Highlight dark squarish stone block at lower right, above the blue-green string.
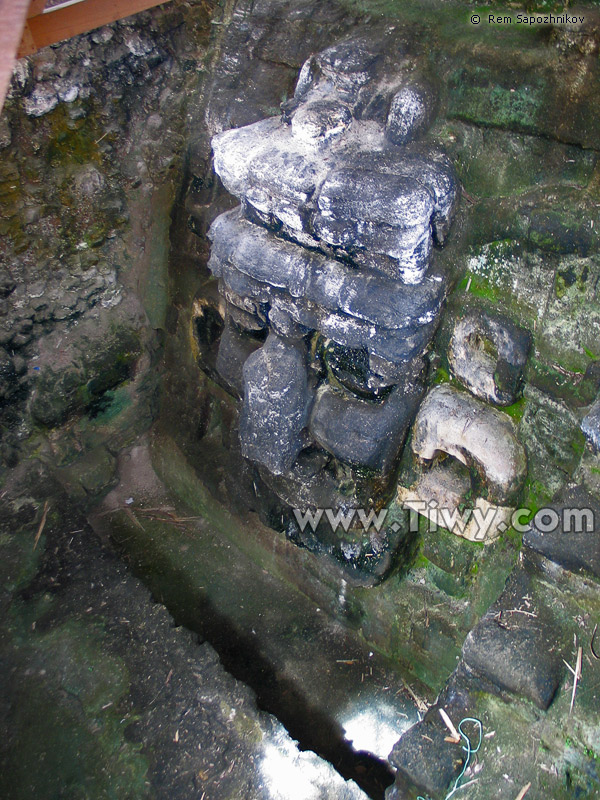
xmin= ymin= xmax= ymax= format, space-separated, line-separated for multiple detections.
xmin=462 ymin=568 xmax=564 ymax=710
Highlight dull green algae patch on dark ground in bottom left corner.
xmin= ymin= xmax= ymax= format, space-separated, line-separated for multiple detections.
xmin=0 ymin=622 xmax=149 ymax=800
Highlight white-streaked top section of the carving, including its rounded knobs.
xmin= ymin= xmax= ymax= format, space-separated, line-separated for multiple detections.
xmin=213 ymin=42 xmax=456 ymax=283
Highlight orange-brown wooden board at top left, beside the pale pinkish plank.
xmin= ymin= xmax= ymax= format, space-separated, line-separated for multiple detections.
xmin=21 ymin=0 xmax=169 ymax=50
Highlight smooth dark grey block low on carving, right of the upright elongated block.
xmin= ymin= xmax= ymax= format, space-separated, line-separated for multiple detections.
xmin=309 ymin=383 xmax=423 ymax=473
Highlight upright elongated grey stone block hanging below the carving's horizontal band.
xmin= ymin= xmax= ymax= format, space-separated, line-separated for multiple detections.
xmin=240 ymin=333 xmax=312 ymax=475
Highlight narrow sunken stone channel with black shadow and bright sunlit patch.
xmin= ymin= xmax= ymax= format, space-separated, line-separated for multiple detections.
xmin=94 ymin=438 xmax=419 ymax=798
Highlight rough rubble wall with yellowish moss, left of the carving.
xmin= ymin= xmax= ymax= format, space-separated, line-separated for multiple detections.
xmin=0 ymin=2 xmax=211 ymax=497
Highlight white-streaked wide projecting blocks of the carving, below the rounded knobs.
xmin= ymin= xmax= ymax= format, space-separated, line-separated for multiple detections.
xmin=213 ymin=120 xmax=457 ymax=283
